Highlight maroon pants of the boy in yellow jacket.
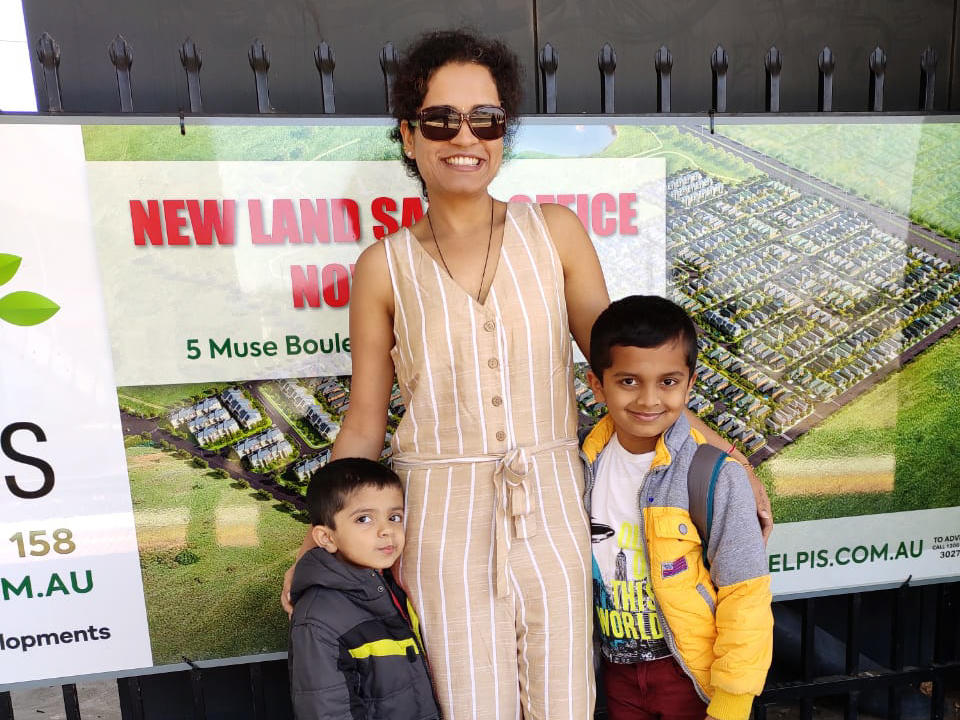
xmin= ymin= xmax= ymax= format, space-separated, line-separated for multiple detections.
xmin=603 ymin=657 xmax=707 ymax=720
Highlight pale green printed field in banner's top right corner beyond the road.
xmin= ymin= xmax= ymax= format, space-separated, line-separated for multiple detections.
xmin=718 ymin=123 xmax=960 ymax=239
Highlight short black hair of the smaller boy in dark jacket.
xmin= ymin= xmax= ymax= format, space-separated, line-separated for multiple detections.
xmin=306 ymin=458 xmax=403 ymax=529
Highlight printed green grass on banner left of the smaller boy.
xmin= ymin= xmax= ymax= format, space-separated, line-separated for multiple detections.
xmin=127 ymin=446 xmax=306 ymax=664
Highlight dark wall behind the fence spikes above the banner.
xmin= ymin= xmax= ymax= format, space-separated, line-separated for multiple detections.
xmin=16 ymin=0 xmax=960 ymax=114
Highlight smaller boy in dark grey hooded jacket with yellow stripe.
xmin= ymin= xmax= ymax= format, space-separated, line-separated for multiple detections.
xmin=290 ymin=458 xmax=440 ymax=720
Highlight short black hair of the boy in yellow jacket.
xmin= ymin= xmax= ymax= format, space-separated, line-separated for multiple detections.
xmin=590 ymin=295 xmax=697 ymax=382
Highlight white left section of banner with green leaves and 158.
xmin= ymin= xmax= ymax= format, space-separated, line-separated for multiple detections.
xmin=0 ymin=125 xmax=151 ymax=683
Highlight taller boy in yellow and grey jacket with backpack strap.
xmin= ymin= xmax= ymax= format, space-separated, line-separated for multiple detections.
xmin=582 ymin=296 xmax=773 ymax=720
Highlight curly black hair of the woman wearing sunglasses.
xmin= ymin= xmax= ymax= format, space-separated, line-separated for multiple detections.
xmin=390 ymin=28 xmax=523 ymax=195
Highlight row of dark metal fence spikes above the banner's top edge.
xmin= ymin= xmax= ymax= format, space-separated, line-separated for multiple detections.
xmin=30 ymin=33 xmax=938 ymax=114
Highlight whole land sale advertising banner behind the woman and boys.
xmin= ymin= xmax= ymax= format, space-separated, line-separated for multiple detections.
xmin=0 ymin=118 xmax=960 ymax=683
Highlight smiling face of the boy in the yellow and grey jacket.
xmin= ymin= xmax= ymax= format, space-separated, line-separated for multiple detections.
xmin=587 ymin=338 xmax=694 ymax=454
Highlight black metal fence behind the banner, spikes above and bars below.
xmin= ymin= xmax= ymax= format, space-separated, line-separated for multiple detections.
xmin=0 ymin=26 xmax=960 ymax=720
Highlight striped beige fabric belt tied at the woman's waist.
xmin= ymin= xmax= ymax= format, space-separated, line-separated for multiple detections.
xmin=393 ymin=438 xmax=577 ymax=599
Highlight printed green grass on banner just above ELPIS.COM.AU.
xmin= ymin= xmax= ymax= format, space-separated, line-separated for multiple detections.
xmin=759 ymin=333 xmax=960 ymax=522
